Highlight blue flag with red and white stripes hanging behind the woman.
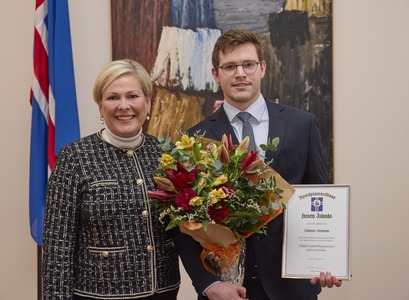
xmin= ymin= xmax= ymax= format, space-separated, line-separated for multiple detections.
xmin=29 ymin=0 xmax=80 ymax=245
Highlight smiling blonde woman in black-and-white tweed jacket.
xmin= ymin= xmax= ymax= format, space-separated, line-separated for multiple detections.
xmin=43 ymin=60 xmax=180 ymax=300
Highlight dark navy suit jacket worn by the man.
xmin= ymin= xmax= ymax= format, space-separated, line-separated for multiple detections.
xmin=175 ymin=101 xmax=327 ymax=300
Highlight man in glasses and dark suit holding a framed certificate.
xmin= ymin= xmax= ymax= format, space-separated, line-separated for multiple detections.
xmin=175 ymin=29 xmax=342 ymax=300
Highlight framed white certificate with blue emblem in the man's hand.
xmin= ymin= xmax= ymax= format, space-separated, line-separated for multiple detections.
xmin=282 ymin=184 xmax=351 ymax=280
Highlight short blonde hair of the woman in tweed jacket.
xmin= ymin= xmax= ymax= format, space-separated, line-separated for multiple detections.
xmin=93 ymin=59 xmax=152 ymax=104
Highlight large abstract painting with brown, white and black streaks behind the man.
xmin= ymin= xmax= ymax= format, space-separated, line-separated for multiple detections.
xmin=111 ymin=0 xmax=333 ymax=182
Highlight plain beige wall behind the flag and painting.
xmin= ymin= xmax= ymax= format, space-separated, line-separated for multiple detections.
xmin=0 ymin=0 xmax=409 ymax=300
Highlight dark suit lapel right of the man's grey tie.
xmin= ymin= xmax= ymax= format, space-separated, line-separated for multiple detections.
xmin=265 ymin=101 xmax=287 ymax=168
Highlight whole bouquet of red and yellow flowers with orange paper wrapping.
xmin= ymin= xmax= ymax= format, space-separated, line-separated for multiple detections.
xmin=149 ymin=134 xmax=294 ymax=284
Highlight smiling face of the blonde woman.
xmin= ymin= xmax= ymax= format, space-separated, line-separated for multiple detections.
xmin=99 ymin=74 xmax=151 ymax=138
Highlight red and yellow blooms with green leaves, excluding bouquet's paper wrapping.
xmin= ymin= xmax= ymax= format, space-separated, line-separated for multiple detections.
xmin=150 ymin=135 xmax=283 ymax=238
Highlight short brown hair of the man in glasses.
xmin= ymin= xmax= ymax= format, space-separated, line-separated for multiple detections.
xmin=212 ymin=29 xmax=263 ymax=69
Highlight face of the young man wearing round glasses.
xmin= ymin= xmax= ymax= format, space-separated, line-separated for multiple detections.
xmin=212 ymin=43 xmax=266 ymax=110
